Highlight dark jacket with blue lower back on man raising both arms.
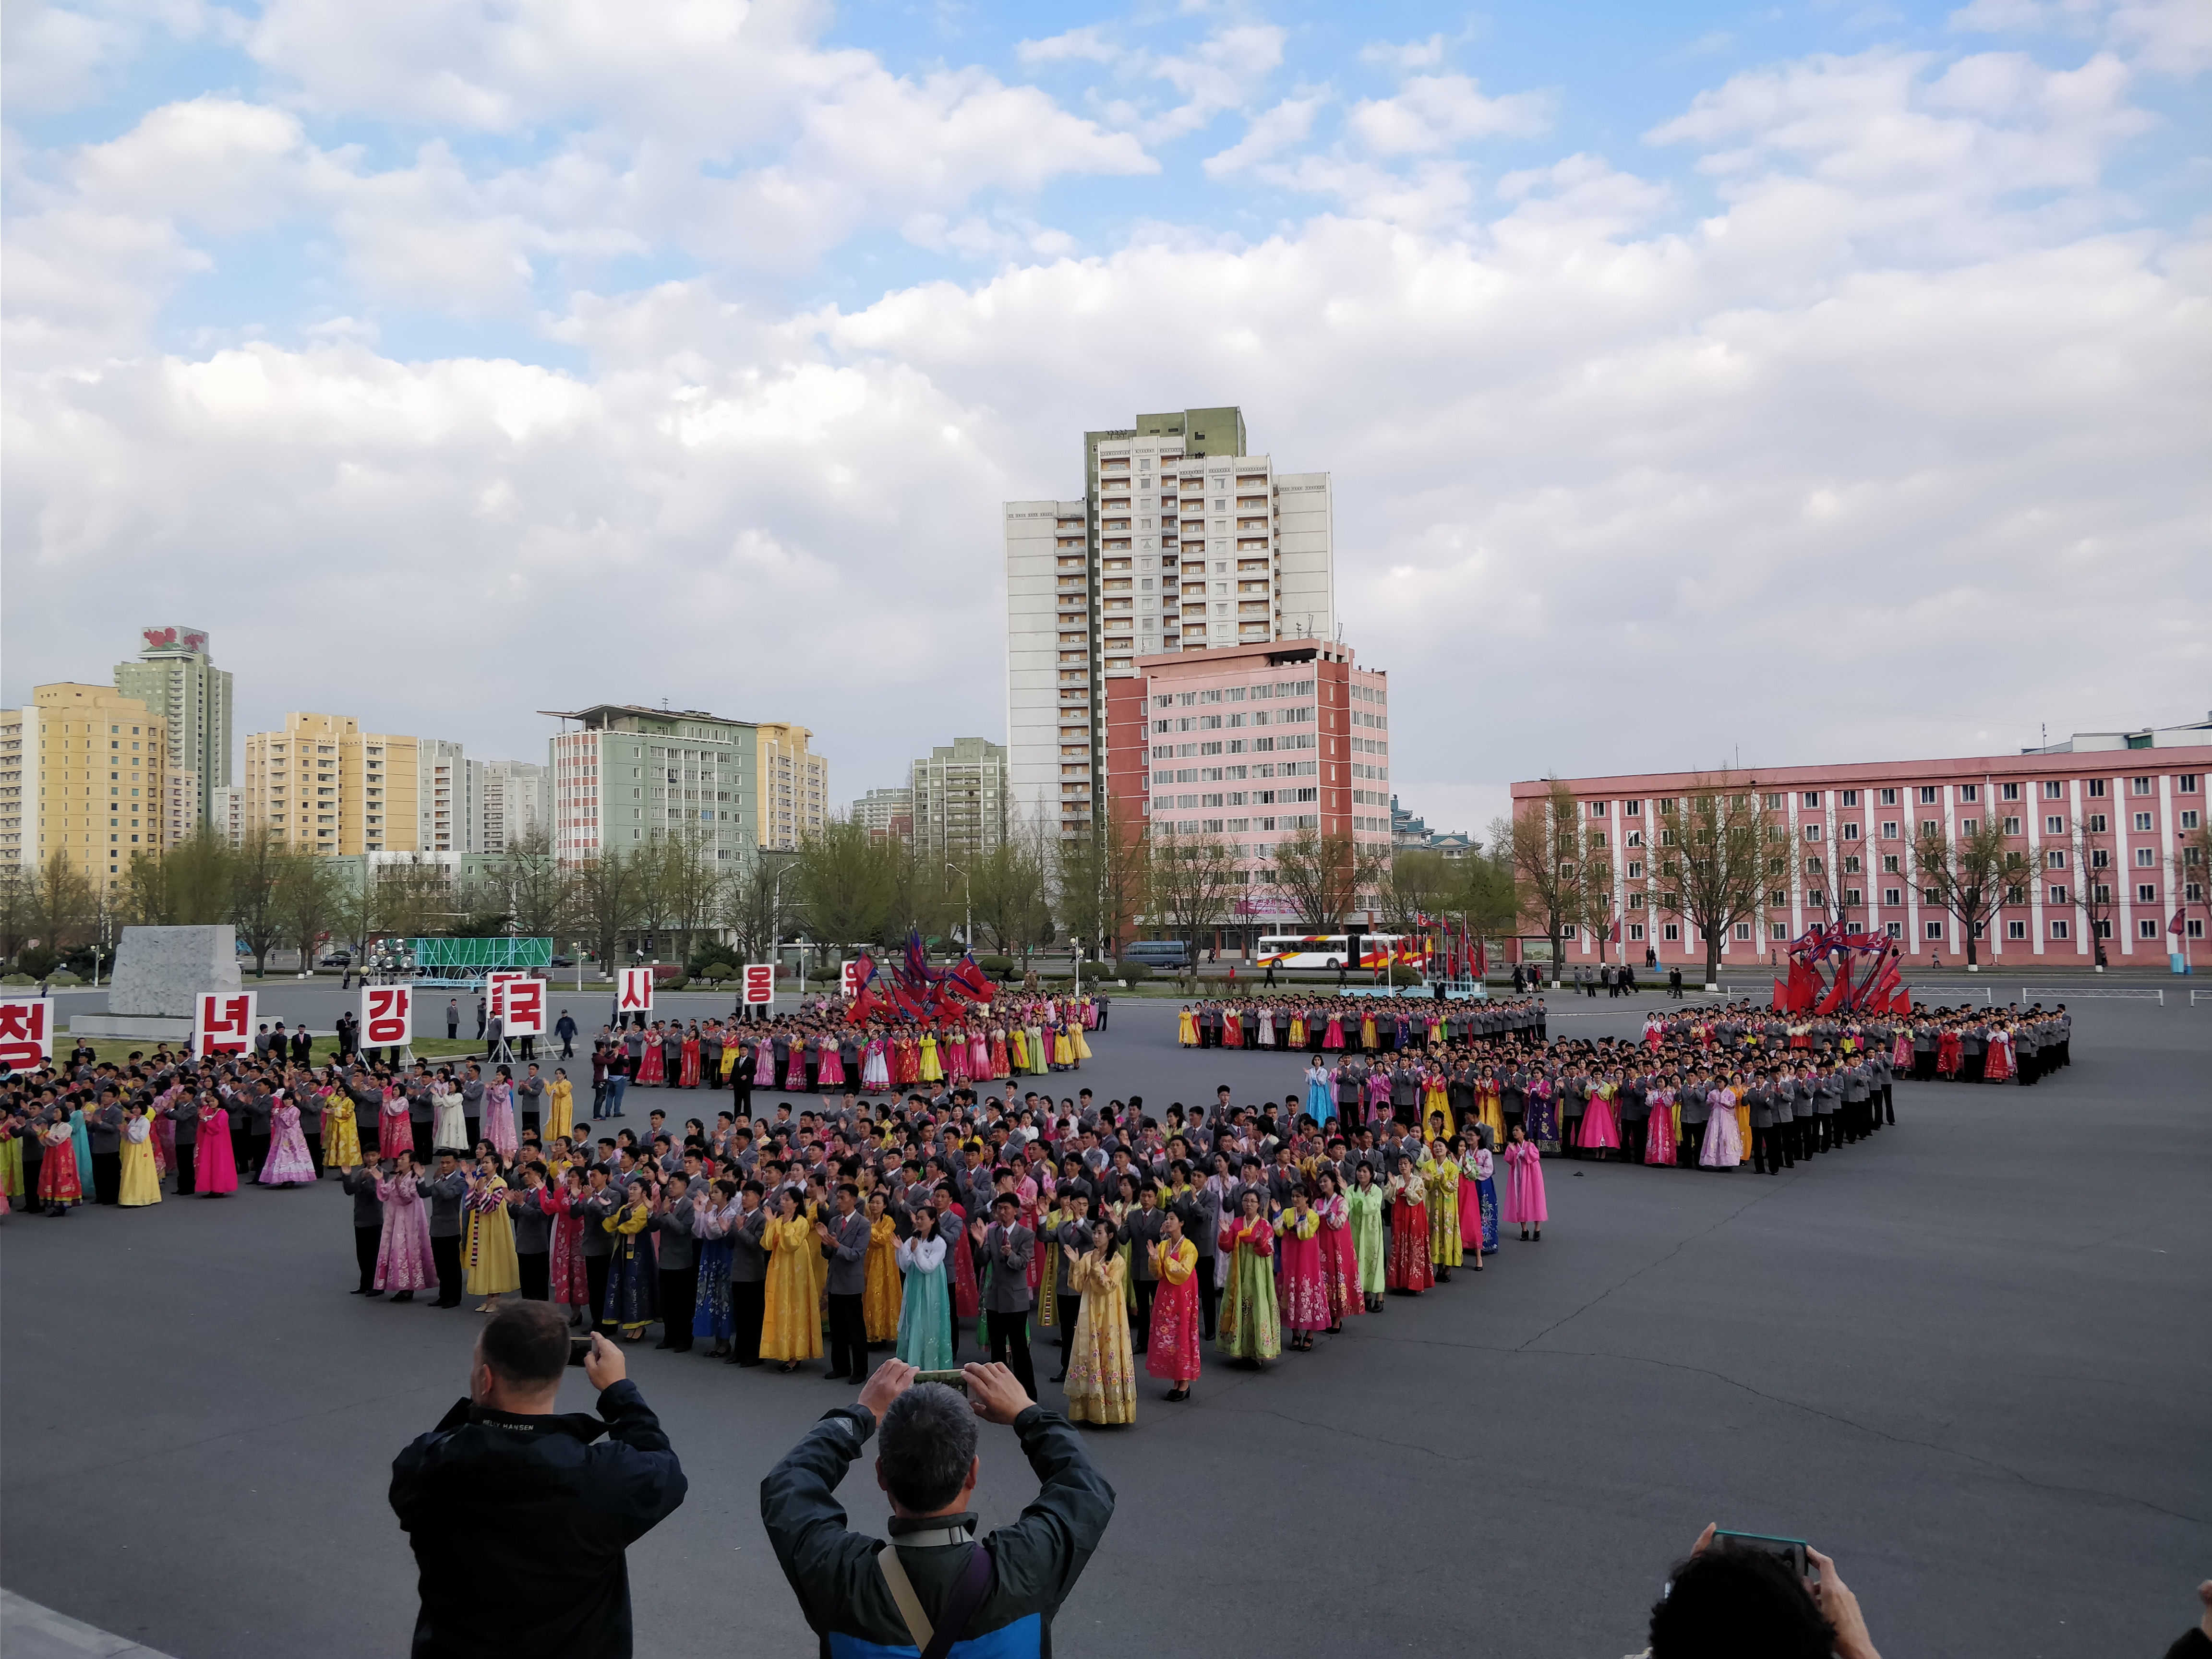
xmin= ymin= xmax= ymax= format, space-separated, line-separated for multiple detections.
xmin=761 ymin=1405 xmax=1113 ymax=1659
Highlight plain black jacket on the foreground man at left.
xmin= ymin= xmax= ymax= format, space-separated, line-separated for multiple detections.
xmin=392 ymin=1380 xmax=685 ymax=1659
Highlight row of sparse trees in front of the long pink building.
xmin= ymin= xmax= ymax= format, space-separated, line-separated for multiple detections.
xmin=1493 ymin=774 xmax=2212 ymax=982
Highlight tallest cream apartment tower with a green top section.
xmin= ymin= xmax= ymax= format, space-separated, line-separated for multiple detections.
xmin=1004 ymin=409 xmax=1336 ymax=836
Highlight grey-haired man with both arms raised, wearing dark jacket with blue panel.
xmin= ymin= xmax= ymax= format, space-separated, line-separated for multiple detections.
xmin=761 ymin=1360 xmax=1115 ymax=1659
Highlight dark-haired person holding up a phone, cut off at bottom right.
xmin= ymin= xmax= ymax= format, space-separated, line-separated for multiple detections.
xmin=1648 ymin=1524 xmax=1882 ymax=1659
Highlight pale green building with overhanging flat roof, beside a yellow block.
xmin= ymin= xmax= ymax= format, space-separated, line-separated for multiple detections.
xmin=540 ymin=703 xmax=765 ymax=865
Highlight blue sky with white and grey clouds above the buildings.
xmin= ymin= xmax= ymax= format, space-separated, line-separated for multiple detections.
xmin=0 ymin=0 xmax=2212 ymax=832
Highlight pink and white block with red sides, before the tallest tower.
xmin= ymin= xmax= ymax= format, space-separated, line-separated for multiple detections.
xmin=1106 ymin=639 xmax=1391 ymax=920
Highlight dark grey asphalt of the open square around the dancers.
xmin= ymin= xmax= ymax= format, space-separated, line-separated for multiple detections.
xmin=0 ymin=998 xmax=2212 ymax=1659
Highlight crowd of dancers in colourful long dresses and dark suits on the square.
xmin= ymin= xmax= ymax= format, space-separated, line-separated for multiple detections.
xmin=0 ymin=998 xmax=2070 ymax=1422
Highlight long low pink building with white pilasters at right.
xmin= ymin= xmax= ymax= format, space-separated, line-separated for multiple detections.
xmin=1513 ymin=717 xmax=2212 ymax=974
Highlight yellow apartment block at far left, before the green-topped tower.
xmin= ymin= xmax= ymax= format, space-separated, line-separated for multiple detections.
xmin=19 ymin=684 xmax=168 ymax=891
